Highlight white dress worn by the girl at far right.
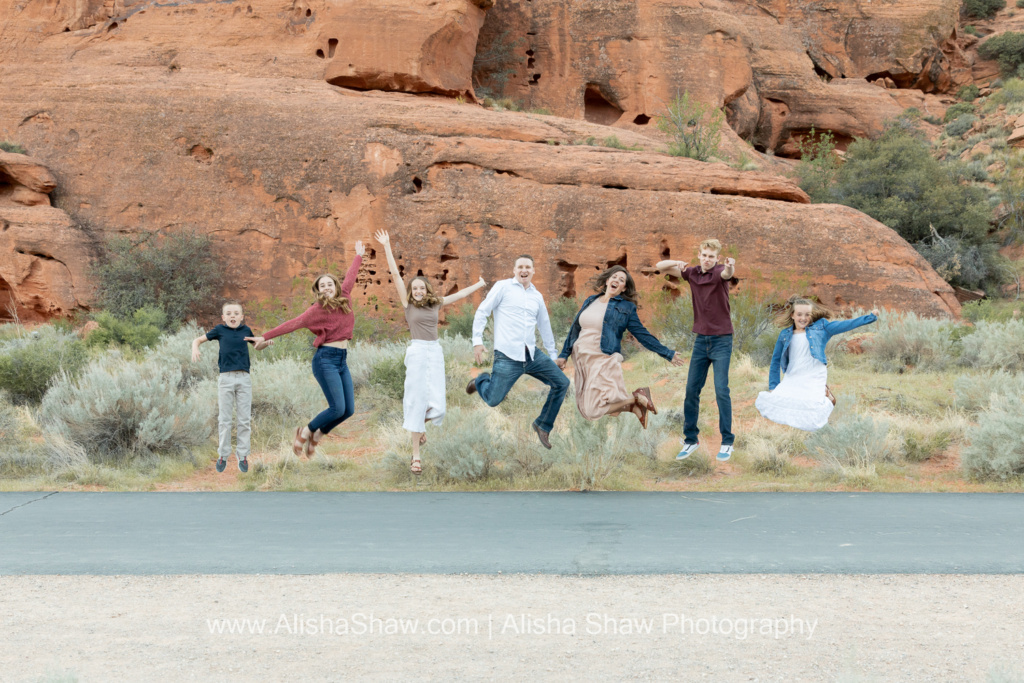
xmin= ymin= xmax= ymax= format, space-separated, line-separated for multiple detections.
xmin=754 ymin=334 xmax=834 ymax=432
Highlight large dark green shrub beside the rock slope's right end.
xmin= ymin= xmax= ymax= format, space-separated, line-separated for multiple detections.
xmin=834 ymin=120 xmax=991 ymax=243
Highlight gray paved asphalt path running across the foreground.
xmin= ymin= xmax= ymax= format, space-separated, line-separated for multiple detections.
xmin=0 ymin=493 xmax=1024 ymax=574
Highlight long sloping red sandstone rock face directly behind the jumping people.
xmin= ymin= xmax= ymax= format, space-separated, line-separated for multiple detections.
xmin=0 ymin=0 xmax=958 ymax=314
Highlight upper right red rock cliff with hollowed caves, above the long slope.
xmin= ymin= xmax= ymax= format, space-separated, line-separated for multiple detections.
xmin=476 ymin=0 xmax=970 ymax=154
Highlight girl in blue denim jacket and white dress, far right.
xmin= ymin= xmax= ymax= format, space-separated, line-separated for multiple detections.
xmin=755 ymin=297 xmax=879 ymax=431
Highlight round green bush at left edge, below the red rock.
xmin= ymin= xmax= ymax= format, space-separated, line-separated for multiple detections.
xmin=0 ymin=325 xmax=86 ymax=403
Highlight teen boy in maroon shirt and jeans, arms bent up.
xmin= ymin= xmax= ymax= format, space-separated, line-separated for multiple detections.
xmin=654 ymin=240 xmax=736 ymax=461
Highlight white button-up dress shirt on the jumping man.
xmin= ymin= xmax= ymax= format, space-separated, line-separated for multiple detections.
xmin=473 ymin=278 xmax=558 ymax=361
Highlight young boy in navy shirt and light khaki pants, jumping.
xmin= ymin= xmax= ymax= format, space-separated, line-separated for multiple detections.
xmin=193 ymin=301 xmax=273 ymax=472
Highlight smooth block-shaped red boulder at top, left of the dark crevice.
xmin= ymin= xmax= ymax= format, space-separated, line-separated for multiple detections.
xmin=321 ymin=0 xmax=494 ymax=99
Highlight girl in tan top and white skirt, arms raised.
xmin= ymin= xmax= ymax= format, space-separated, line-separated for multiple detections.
xmin=374 ymin=230 xmax=486 ymax=474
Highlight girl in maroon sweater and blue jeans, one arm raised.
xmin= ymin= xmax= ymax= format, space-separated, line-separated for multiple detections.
xmin=246 ymin=242 xmax=366 ymax=457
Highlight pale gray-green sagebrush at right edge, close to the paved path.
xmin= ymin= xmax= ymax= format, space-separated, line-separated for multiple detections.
xmin=961 ymin=394 xmax=1024 ymax=480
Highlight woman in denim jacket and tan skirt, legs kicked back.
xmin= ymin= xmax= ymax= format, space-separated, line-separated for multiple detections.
xmin=555 ymin=265 xmax=682 ymax=429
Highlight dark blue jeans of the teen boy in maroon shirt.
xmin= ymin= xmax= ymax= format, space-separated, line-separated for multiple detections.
xmin=683 ymin=335 xmax=736 ymax=445
